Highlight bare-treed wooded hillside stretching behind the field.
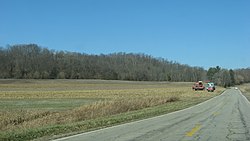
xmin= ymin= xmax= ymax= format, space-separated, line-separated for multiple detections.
xmin=0 ymin=44 xmax=250 ymax=87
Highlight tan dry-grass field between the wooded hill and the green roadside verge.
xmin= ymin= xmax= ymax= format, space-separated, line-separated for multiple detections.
xmin=0 ymin=80 xmax=223 ymax=139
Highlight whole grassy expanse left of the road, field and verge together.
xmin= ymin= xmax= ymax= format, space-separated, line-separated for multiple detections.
xmin=0 ymin=80 xmax=224 ymax=141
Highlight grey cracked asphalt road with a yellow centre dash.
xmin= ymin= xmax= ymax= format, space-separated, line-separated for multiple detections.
xmin=56 ymin=88 xmax=250 ymax=141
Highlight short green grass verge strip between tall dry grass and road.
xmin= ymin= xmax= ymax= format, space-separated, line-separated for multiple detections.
xmin=0 ymin=100 xmax=207 ymax=141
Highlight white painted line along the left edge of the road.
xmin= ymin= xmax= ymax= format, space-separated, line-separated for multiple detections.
xmin=52 ymin=90 xmax=229 ymax=141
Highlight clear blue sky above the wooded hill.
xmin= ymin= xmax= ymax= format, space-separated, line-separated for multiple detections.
xmin=0 ymin=0 xmax=250 ymax=69
